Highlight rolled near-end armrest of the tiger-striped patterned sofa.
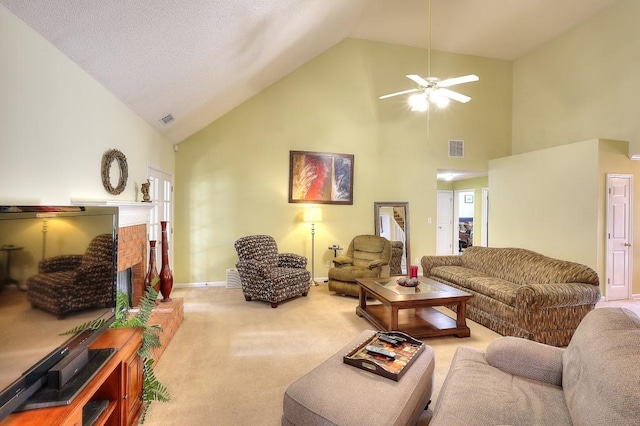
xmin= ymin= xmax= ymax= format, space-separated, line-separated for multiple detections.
xmin=516 ymin=283 xmax=600 ymax=309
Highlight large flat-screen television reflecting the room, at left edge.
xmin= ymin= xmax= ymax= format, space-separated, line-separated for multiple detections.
xmin=0 ymin=206 xmax=118 ymax=421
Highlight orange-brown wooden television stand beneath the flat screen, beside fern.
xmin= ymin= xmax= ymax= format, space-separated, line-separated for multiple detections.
xmin=0 ymin=328 xmax=142 ymax=426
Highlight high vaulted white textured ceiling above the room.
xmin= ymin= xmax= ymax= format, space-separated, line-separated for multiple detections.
xmin=0 ymin=0 xmax=619 ymax=143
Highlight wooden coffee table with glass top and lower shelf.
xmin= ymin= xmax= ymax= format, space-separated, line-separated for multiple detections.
xmin=356 ymin=277 xmax=472 ymax=338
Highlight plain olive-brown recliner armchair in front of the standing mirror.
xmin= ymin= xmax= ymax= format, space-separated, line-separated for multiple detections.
xmin=328 ymin=235 xmax=391 ymax=296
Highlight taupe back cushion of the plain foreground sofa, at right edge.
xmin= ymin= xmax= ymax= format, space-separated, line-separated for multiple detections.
xmin=562 ymin=308 xmax=640 ymax=425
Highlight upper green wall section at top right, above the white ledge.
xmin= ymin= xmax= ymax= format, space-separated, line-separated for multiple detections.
xmin=513 ymin=0 xmax=640 ymax=154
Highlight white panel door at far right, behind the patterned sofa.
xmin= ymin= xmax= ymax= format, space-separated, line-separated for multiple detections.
xmin=606 ymin=174 xmax=633 ymax=300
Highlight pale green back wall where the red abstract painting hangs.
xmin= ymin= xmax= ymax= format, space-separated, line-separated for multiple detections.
xmin=174 ymin=39 xmax=511 ymax=283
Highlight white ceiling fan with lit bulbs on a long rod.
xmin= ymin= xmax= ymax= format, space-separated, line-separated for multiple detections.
xmin=379 ymin=0 xmax=480 ymax=111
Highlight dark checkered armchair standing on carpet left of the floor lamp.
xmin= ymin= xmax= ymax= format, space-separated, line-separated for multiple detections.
xmin=234 ymin=235 xmax=311 ymax=308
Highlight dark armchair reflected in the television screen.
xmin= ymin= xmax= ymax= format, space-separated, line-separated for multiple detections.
xmin=27 ymin=234 xmax=115 ymax=318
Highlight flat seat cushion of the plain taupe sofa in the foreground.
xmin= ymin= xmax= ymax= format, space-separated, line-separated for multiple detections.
xmin=429 ymin=347 xmax=571 ymax=426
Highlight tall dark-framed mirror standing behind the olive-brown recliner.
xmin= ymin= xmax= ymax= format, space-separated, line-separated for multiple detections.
xmin=373 ymin=201 xmax=411 ymax=275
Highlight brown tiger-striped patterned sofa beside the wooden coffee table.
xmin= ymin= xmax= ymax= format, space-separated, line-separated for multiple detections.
xmin=421 ymin=246 xmax=600 ymax=346
